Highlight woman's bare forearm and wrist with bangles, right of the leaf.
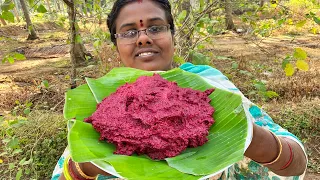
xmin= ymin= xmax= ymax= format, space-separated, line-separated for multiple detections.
xmin=245 ymin=124 xmax=307 ymax=176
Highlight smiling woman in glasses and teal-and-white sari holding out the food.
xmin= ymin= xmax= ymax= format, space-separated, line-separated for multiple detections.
xmin=53 ymin=0 xmax=307 ymax=179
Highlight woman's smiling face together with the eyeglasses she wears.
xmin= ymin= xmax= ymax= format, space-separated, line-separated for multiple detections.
xmin=108 ymin=1 xmax=174 ymax=71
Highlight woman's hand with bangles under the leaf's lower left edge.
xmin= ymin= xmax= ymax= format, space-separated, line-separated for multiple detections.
xmin=59 ymin=161 xmax=111 ymax=180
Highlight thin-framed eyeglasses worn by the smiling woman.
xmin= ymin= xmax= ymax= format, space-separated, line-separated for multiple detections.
xmin=114 ymin=24 xmax=170 ymax=44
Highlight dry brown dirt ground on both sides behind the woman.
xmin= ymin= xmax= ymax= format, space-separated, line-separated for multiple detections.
xmin=0 ymin=24 xmax=320 ymax=179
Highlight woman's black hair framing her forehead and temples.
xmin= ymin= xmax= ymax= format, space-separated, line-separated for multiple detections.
xmin=107 ymin=0 xmax=175 ymax=45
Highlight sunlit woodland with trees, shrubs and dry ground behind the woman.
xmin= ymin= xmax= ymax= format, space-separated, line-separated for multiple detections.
xmin=0 ymin=0 xmax=320 ymax=179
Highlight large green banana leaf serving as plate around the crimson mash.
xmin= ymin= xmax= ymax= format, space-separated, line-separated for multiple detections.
xmin=64 ymin=68 xmax=248 ymax=180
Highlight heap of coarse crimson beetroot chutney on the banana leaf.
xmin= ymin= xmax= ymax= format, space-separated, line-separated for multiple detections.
xmin=85 ymin=74 xmax=214 ymax=159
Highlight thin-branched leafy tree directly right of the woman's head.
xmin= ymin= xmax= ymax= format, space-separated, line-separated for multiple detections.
xmin=173 ymin=0 xmax=220 ymax=64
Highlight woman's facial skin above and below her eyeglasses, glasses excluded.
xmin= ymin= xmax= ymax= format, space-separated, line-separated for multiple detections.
xmin=116 ymin=0 xmax=174 ymax=71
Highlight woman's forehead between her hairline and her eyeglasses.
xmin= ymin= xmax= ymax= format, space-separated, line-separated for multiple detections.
xmin=116 ymin=0 xmax=167 ymax=29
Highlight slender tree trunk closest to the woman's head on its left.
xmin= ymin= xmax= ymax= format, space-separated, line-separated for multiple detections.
xmin=63 ymin=0 xmax=86 ymax=88
